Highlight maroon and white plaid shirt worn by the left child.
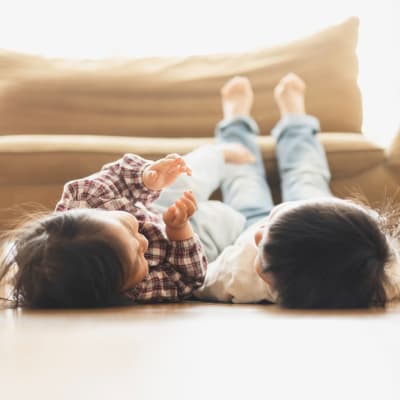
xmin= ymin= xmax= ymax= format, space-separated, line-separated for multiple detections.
xmin=56 ymin=154 xmax=207 ymax=302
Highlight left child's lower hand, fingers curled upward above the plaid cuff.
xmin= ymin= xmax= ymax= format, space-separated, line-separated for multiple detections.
xmin=163 ymin=190 xmax=197 ymax=240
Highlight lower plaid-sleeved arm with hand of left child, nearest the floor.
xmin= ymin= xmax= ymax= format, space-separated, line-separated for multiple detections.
xmin=128 ymin=191 xmax=207 ymax=302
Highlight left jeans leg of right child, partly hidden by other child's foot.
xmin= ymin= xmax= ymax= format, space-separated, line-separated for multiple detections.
xmin=216 ymin=117 xmax=274 ymax=227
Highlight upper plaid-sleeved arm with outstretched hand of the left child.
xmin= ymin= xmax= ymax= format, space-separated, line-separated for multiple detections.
xmin=56 ymin=154 xmax=190 ymax=212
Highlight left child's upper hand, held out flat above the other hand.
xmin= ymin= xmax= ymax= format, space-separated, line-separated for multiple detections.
xmin=143 ymin=154 xmax=192 ymax=190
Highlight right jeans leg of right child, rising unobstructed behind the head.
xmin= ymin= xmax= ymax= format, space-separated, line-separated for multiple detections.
xmin=272 ymin=114 xmax=333 ymax=201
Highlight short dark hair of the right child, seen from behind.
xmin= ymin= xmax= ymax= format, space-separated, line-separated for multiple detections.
xmin=262 ymin=202 xmax=391 ymax=308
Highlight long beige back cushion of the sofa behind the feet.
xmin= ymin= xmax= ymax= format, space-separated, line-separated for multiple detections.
xmin=0 ymin=18 xmax=362 ymax=137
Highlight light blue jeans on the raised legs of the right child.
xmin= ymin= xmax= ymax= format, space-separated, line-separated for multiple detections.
xmin=216 ymin=115 xmax=332 ymax=227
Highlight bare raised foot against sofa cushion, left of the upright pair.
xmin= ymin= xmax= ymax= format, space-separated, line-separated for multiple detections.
xmin=221 ymin=76 xmax=254 ymax=119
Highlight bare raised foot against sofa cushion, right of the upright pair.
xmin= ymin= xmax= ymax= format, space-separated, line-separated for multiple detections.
xmin=274 ymin=73 xmax=306 ymax=117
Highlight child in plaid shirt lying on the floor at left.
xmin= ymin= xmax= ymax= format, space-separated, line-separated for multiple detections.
xmin=0 ymin=143 xmax=252 ymax=308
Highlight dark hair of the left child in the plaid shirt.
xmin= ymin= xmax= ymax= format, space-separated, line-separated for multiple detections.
xmin=0 ymin=212 xmax=124 ymax=308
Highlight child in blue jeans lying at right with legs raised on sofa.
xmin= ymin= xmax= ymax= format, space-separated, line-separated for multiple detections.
xmin=195 ymin=74 xmax=400 ymax=308
